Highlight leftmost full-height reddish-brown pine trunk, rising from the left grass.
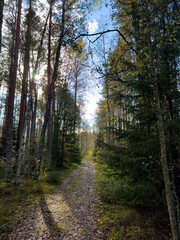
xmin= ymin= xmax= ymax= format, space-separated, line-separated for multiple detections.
xmin=5 ymin=0 xmax=22 ymax=181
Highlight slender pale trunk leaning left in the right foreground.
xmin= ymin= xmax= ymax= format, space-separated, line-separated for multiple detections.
xmin=145 ymin=5 xmax=179 ymax=240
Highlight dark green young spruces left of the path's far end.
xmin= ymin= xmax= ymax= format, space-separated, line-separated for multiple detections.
xmin=52 ymin=85 xmax=82 ymax=168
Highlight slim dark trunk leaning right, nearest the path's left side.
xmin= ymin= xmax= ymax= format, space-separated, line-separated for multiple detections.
xmin=34 ymin=0 xmax=66 ymax=180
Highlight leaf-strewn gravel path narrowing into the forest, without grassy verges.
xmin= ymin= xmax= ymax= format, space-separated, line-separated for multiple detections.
xmin=8 ymin=157 xmax=103 ymax=240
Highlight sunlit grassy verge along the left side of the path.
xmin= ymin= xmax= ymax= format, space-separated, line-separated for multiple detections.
xmin=0 ymin=162 xmax=77 ymax=239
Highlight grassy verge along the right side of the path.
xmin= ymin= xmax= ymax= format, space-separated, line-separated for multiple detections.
xmin=94 ymin=156 xmax=172 ymax=240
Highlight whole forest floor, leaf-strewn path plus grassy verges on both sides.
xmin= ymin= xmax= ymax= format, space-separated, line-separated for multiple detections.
xmin=0 ymin=156 xmax=172 ymax=240
